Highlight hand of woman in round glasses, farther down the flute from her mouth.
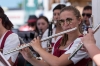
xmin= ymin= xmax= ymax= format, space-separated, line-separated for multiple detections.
xmin=20 ymin=45 xmax=33 ymax=60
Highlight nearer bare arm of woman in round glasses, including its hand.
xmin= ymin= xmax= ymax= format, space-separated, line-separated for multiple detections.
xmin=31 ymin=38 xmax=72 ymax=66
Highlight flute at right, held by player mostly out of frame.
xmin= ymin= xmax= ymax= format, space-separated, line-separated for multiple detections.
xmin=68 ymin=24 xmax=100 ymax=60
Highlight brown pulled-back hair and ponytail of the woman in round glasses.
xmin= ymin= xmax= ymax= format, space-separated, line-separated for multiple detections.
xmin=60 ymin=6 xmax=81 ymax=46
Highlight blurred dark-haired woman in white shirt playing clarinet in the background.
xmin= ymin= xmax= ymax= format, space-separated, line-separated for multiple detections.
xmin=36 ymin=16 xmax=49 ymax=49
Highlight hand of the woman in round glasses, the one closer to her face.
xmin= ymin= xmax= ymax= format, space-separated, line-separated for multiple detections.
xmin=30 ymin=37 xmax=42 ymax=51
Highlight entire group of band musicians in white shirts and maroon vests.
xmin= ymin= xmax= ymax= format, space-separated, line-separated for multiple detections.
xmin=0 ymin=4 xmax=100 ymax=66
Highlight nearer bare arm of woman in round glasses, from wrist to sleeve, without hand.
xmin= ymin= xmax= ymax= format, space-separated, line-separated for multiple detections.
xmin=37 ymin=48 xmax=72 ymax=66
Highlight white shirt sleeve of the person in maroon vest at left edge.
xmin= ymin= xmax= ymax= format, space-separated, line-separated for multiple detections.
xmin=3 ymin=33 xmax=20 ymax=62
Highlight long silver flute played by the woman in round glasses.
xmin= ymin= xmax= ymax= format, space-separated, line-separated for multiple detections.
xmin=4 ymin=27 xmax=77 ymax=55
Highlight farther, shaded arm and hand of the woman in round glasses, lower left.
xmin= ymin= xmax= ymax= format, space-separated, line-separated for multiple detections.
xmin=20 ymin=48 xmax=49 ymax=66
